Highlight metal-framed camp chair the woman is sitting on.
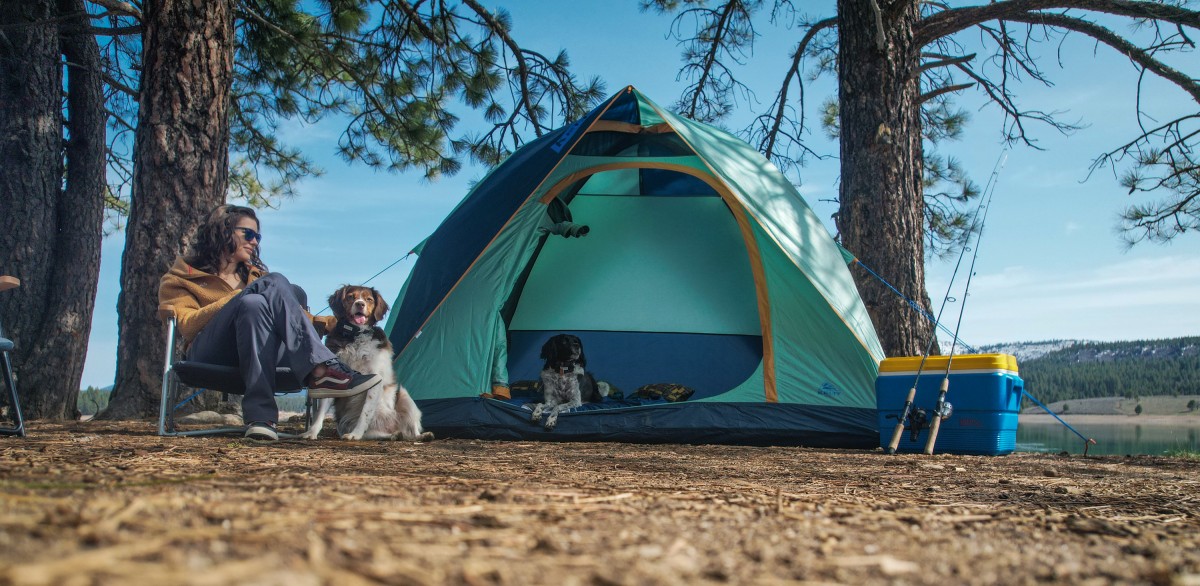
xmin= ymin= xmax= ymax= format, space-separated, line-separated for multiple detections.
xmin=158 ymin=305 xmax=312 ymax=437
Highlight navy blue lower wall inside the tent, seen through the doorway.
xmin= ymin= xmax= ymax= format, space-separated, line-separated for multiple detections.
xmin=508 ymin=330 xmax=762 ymax=400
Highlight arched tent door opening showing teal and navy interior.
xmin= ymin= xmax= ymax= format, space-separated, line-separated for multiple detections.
xmin=505 ymin=168 xmax=763 ymax=400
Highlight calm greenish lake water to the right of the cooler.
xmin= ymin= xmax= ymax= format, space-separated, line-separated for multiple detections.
xmin=1016 ymin=421 xmax=1200 ymax=455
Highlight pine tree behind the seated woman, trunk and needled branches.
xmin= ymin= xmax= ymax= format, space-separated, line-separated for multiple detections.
xmin=94 ymin=0 xmax=604 ymax=418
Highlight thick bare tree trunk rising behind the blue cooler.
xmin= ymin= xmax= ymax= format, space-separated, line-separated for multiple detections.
xmin=838 ymin=0 xmax=937 ymax=355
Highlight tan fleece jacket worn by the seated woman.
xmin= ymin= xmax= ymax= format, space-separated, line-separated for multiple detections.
xmin=158 ymin=257 xmax=337 ymax=343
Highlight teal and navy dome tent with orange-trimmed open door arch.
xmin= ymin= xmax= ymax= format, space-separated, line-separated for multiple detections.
xmin=388 ymin=86 xmax=883 ymax=447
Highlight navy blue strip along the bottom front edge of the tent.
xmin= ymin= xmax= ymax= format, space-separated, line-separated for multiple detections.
xmin=416 ymin=399 xmax=880 ymax=449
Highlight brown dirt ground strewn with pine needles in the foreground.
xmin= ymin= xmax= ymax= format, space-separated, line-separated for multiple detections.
xmin=0 ymin=421 xmax=1200 ymax=586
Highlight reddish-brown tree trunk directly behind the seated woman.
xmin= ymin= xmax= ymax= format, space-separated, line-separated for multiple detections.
xmin=101 ymin=0 xmax=234 ymax=419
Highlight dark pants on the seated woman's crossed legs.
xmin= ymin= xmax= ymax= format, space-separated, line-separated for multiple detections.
xmin=187 ymin=273 xmax=334 ymax=423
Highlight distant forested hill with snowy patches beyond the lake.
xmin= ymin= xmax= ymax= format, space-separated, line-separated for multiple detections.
xmin=979 ymin=336 xmax=1200 ymax=403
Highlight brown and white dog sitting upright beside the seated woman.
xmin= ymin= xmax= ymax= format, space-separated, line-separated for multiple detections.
xmin=301 ymin=285 xmax=433 ymax=441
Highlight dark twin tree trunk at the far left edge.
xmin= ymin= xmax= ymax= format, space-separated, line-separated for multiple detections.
xmin=0 ymin=0 xmax=104 ymax=419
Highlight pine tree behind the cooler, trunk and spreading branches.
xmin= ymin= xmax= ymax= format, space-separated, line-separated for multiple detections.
xmin=643 ymin=0 xmax=1200 ymax=355
